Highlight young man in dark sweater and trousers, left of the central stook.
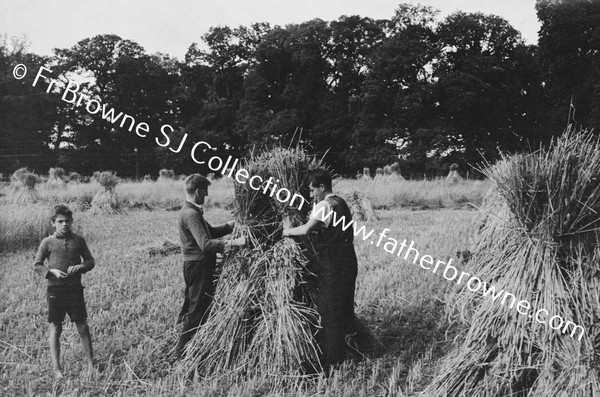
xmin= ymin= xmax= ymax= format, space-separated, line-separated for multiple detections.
xmin=175 ymin=174 xmax=246 ymax=358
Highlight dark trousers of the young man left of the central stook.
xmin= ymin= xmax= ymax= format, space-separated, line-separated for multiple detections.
xmin=176 ymin=261 xmax=216 ymax=357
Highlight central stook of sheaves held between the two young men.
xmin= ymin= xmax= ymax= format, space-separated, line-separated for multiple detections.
xmin=183 ymin=147 xmax=328 ymax=376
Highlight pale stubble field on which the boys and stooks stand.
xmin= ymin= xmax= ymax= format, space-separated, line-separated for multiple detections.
xmin=0 ymin=181 xmax=489 ymax=396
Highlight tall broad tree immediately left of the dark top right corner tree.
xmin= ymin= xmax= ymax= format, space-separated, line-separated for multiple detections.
xmin=403 ymin=12 xmax=541 ymax=171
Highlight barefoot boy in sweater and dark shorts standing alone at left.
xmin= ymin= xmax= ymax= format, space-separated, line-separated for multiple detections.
xmin=34 ymin=205 xmax=95 ymax=378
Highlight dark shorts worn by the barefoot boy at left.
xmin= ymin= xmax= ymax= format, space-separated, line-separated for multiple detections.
xmin=47 ymin=285 xmax=87 ymax=323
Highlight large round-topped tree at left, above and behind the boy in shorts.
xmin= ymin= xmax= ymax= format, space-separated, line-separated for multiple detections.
xmin=56 ymin=35 xmax=178 ymax=176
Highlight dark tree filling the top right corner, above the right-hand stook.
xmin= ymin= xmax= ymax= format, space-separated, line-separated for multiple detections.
xmin=536 ymin=0 xmax=600 ymax=133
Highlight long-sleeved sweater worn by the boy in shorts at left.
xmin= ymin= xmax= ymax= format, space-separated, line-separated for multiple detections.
xmin=33 ymin=233 xmax=95 ymax=286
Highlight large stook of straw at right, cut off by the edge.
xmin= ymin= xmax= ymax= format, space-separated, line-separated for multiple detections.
xmin=422 ymin=131 xmax=600 ymax=397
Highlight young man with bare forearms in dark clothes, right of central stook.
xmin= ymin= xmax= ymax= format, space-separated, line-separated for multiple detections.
xmin=283 ymin=168 xmax=357 ymax=369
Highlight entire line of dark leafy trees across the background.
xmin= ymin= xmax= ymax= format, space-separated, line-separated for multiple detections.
xmin=0 ymin=0 xmax=600 ymax=177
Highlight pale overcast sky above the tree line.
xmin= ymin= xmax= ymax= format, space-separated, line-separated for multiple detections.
xmin=0 ymin=0 xmax=539 ymax=59
